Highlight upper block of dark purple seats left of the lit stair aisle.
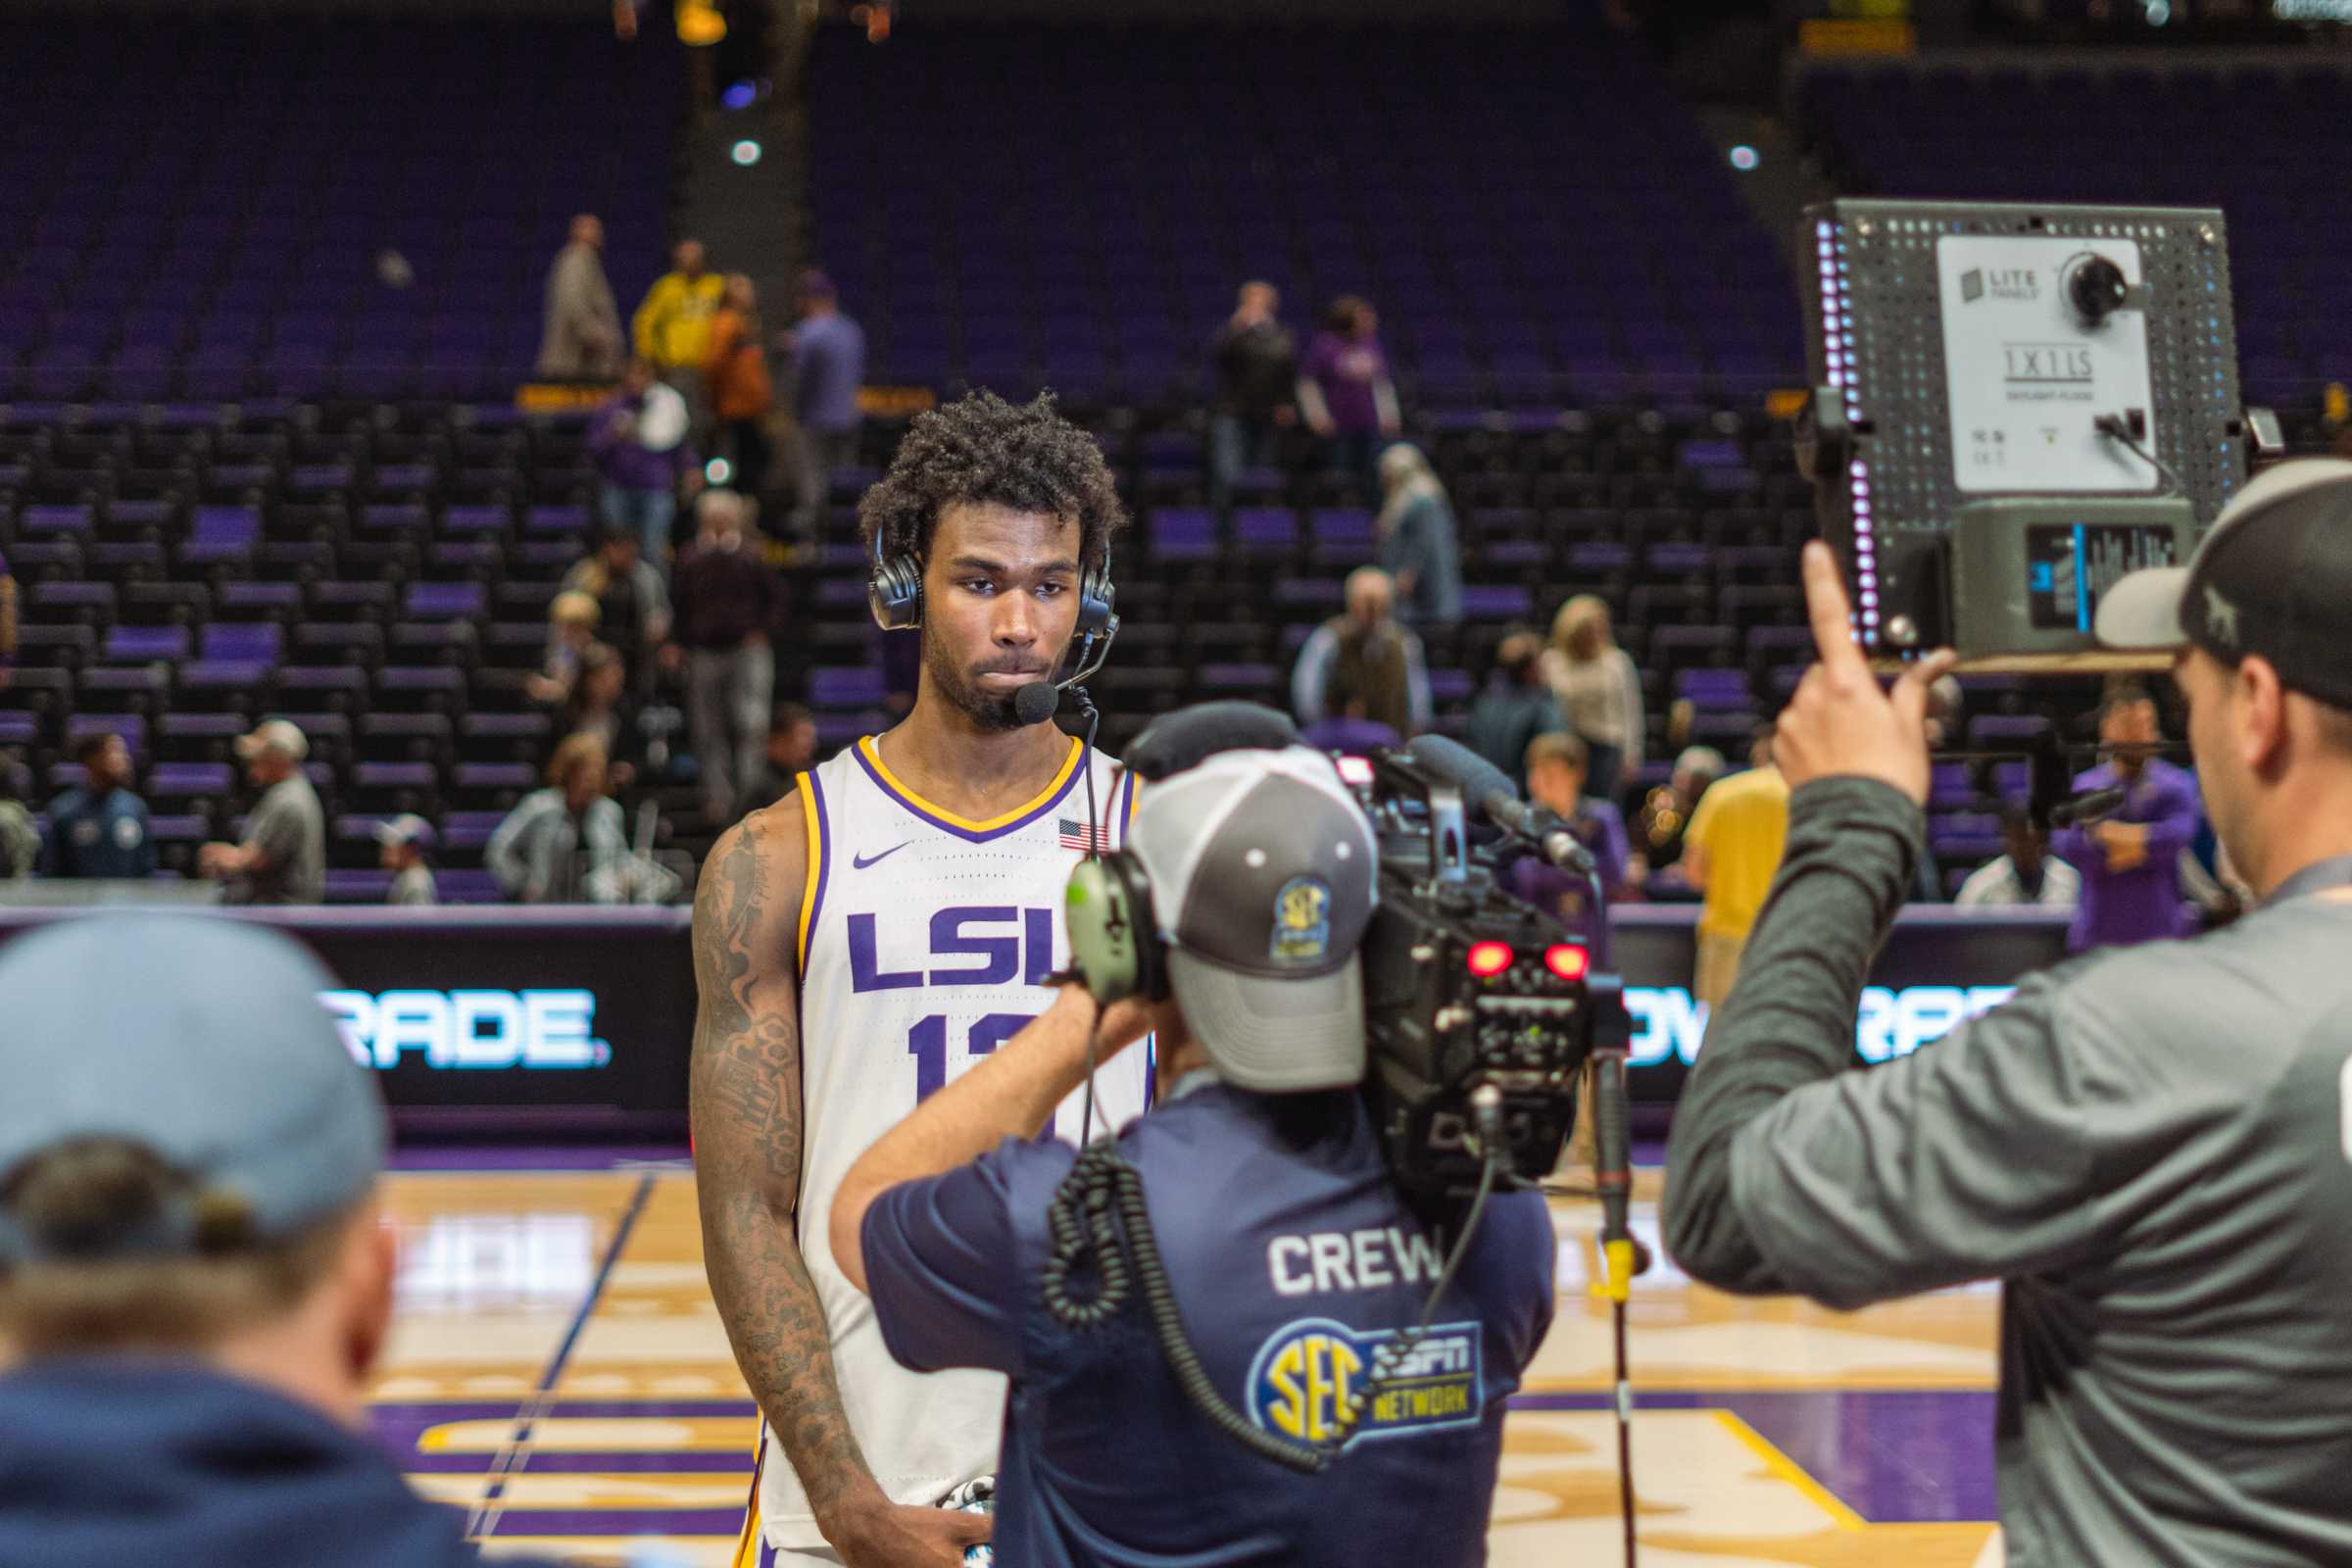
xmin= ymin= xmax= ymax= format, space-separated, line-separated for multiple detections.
xmin=0 ymin=14 xmax=680 ymax=404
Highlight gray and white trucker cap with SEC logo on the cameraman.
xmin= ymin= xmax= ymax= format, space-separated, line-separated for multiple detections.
xmin=1129 ymin=745 xmax=1378 ymax=1093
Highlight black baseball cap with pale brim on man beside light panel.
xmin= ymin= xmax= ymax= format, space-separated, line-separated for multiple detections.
xmin=2098 ymin=459 xmax=2352 ymax=708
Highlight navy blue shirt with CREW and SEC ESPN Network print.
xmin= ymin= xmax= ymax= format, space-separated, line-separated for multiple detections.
xmin=863 ymin=1081 xmax=1554 ymax=1568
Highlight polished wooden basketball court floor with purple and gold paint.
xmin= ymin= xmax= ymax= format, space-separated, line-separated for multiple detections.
xmin=374 ymin=1161 xmax=1999 ymax=1568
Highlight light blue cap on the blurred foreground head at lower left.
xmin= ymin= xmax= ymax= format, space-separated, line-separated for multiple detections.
xmin=0 ymin=914 xmax=386 ymax=1265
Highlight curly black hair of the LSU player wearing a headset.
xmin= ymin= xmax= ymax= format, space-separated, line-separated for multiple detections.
xmin=858 ymin=393 xmax=1127 ymax=571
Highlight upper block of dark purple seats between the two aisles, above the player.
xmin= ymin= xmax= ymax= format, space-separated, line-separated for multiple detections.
xmin=809 ymin=19 xmax=1804 ymax=409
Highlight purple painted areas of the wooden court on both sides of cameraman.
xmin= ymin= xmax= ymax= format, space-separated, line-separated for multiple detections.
xmin=369 ymin=1392 xmax=1997 ymax=1535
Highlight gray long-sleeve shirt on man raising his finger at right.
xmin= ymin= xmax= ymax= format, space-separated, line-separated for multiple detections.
xmin=1665 ymin=778 xmax=2352 ymax=1568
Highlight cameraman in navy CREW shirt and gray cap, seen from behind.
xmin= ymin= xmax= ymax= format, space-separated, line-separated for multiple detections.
xmin=833 ymin=748 xmax=1554 ymax=1568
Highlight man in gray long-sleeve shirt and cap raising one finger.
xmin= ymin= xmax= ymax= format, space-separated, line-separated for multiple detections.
xmin=1665 ymin=461 xmax=2352 ymax=1568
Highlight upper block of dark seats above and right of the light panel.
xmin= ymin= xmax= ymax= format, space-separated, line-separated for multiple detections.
xmin=1801 ymin=52 xmax=2352 ymax=402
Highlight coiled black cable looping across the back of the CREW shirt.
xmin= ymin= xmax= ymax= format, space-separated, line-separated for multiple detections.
xmin=1040 ymin=1138 xmax=1503 ymax=1476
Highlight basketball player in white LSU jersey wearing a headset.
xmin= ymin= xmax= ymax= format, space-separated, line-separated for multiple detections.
xmin=692 ymin=393 xmax=1151 ymax=1568
